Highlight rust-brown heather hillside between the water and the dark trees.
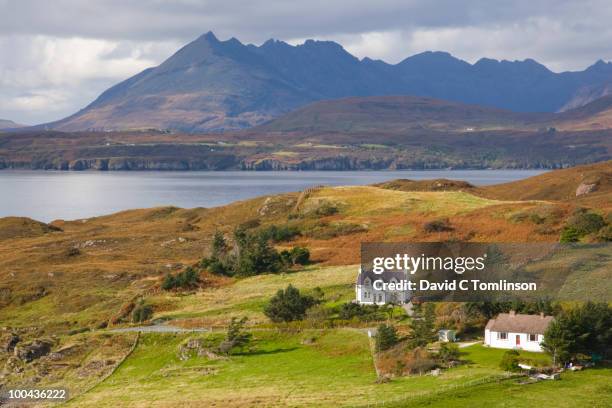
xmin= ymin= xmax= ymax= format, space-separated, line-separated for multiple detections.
xmin=0 ymin=163 xmax=610 ymax=332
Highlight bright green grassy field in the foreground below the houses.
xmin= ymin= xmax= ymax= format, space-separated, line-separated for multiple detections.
xmin=68 ymin=329 xmax=612 ymax=407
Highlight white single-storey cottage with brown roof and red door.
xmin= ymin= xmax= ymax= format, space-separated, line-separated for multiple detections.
xmin=484 ymin=311 xmax=553 ymax=351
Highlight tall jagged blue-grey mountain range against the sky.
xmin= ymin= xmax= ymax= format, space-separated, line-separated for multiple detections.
xmin=39 ymin=32 xmax=612 ymax=132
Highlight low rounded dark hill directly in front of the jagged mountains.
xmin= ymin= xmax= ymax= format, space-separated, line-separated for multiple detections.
xmin=254 ymin=96 xmax=544 ymax=133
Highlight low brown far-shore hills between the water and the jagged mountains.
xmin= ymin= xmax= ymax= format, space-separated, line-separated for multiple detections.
xmin=0 ymin=96 xmax=612 ymax=170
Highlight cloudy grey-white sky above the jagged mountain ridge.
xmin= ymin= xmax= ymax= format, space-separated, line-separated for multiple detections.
xmin=0 ymin=0 xmax=612 ymax=124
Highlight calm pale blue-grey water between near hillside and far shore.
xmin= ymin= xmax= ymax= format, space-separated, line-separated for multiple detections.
xmin=0 ymin=170 xmax=542 ymax=222
